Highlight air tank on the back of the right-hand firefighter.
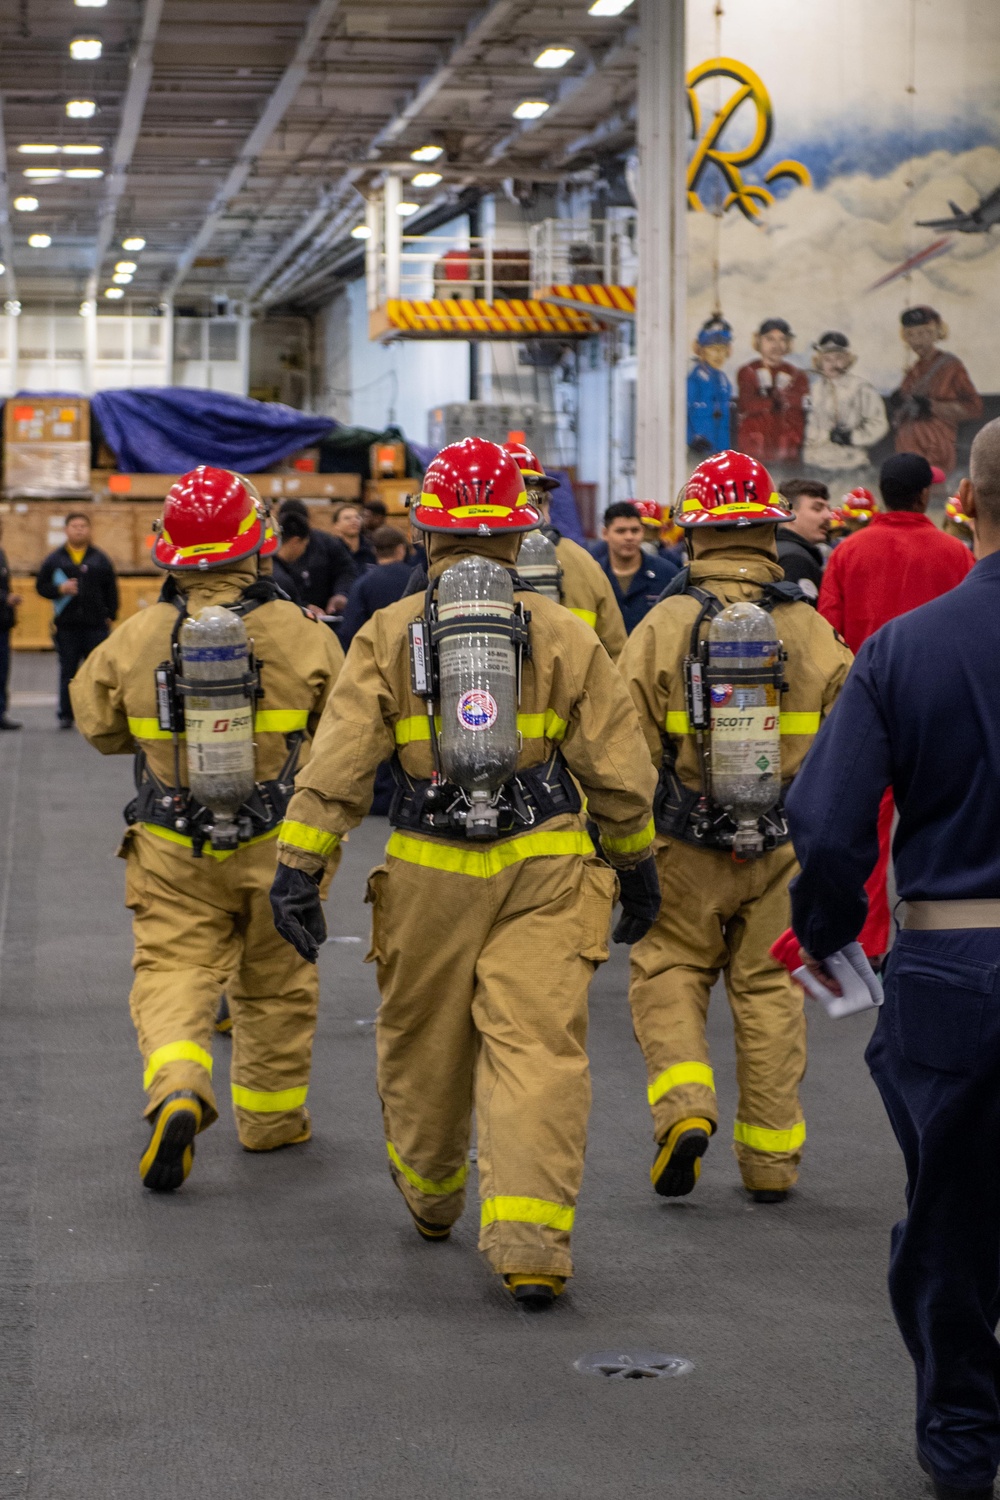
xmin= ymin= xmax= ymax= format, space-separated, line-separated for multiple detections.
xmin=708 ymin=603 xmax=781 ymax=858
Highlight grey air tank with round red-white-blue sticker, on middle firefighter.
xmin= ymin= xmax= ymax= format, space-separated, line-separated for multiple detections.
xmin=435 ymin=558 xmax=519 ymax=839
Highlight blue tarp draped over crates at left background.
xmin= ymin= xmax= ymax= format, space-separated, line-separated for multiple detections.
xmin=90 ymin=386 xmax=337 ymax=474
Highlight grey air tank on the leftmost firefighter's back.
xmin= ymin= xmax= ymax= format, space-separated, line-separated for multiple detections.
xmin=178 ymin=605 xmax=255 ymax=849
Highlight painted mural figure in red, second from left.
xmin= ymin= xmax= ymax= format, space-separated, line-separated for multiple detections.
xmin=736 ymin=318 xmax=810 ymax=465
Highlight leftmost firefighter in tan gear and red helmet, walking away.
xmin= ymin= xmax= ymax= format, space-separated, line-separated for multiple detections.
xmin=72 ymin=468 xmax=343 ymax=1191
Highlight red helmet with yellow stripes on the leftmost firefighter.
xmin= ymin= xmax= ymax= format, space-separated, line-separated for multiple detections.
xmin=153 ymin=464 xmax=279 ymax=572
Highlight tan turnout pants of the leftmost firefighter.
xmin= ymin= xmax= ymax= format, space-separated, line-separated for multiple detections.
xmin=123 ymin=828 xmax=319 ymax=1151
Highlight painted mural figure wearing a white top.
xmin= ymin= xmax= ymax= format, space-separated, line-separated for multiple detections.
xmin=802 ymin=330 xmax=889 ymax=473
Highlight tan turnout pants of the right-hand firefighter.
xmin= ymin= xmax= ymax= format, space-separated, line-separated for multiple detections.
xmin=628 ymin=839 xmax=805 ymax=1188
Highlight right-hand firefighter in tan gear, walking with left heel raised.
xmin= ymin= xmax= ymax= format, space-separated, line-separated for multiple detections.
xmin=619 ymin=452 xmax=852 ymax=1203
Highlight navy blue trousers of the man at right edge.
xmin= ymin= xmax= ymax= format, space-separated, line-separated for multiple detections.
xmin=867 ymin=929 xmax=1000 ymax=1488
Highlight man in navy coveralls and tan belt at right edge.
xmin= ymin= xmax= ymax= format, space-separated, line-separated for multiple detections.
xmin=786 ymin=420 xmax=1000 ymax=1500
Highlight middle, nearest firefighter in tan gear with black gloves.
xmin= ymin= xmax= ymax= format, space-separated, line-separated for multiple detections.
xmin=273 ymin=438 xmax=660 ymax=1308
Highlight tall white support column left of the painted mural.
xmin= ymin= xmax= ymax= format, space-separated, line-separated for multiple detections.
xmin=636 ymin=0 xmax=688 ymax=504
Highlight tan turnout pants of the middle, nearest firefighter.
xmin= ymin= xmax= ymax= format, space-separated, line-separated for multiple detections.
xmin=367 ymin=836 xmax=616 ymax=1277
